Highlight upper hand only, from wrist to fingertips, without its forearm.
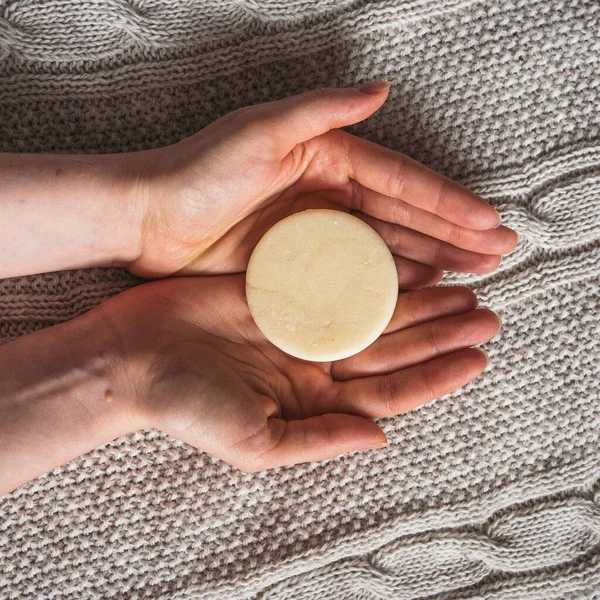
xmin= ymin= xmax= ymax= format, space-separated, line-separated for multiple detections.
xmin=129 ymin=85 xmax=517 ymax=288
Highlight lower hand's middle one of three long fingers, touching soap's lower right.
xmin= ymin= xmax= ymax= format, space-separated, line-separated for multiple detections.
xmin=331 ymin=309 xmax=500 ymax=381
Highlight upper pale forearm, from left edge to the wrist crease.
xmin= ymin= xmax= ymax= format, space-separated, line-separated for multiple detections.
xmin=0 ymin=153 xmax=144 ymax=278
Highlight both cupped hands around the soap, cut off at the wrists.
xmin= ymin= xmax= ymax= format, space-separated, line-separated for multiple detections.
xmin=94 ymin=84 xmax=517 ymax=471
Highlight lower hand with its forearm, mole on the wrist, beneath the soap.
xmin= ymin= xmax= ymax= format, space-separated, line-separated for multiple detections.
xmin=0 ymin=275 xmax=499 ymax=495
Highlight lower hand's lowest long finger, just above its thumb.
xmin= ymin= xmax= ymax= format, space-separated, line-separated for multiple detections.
xmin=330 ymin=348 xmax=487 ymax=418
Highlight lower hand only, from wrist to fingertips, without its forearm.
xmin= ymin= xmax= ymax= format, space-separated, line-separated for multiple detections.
xmin=100 ymin=275 xmax=499 ymax=471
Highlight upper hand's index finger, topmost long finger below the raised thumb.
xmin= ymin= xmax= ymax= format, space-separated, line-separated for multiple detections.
xmin=336 ymin=132 xmax=500 ymax=229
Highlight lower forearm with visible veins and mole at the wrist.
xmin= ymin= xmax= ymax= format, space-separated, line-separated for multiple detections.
xmin=0 ymin=311 xmax=140 ymax=495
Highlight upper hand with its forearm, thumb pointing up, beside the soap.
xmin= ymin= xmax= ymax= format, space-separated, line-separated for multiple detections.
xmin=0 ymin=86 xmax=517 ymax=288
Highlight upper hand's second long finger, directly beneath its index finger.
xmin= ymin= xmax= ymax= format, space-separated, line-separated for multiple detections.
xmin=352 ymin=181 xmax=519 ymax=254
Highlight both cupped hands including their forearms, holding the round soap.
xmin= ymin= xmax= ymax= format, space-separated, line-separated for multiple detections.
xmin=0 ymin=82 xmax=517 ymax=492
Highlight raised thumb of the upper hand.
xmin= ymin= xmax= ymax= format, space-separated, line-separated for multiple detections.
xmin=225 ymin=81 xmax=390 ymax=158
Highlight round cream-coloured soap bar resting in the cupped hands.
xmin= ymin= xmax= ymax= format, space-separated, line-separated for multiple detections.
xmin=246 ymin=209 xmax=398 ymax=362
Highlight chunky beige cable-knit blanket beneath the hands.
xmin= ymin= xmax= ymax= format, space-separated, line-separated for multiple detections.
xmin=0 ymin=0 xmax=600 ymax=600
